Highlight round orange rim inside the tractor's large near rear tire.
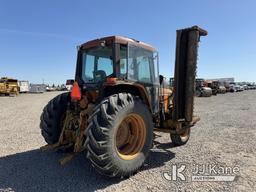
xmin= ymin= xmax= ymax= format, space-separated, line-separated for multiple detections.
xmin=115 ymin=114 xmax=146 ymax=160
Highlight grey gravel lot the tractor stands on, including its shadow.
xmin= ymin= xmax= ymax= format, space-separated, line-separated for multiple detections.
xmin=0 ymin=90 xmax=256 ymax=192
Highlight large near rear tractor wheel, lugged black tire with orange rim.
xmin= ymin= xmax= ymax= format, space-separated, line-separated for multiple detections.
xmin=86 ymin=93 xmax=153 ymax=177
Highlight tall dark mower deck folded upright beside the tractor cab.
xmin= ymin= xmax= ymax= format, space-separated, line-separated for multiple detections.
xmin=172 ymin=26 xmax=208 ymax=123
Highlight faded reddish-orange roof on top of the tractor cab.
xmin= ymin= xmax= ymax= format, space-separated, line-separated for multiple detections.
xmin=81 ymin=36 xmax=156 ymax=51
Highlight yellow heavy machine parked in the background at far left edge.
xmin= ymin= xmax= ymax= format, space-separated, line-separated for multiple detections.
xmin=0 ymin=77 xmax=19 ymax=95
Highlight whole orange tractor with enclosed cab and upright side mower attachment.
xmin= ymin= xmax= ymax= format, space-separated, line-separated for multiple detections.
xmin=40 ymin=26 xmax=207 ymax=177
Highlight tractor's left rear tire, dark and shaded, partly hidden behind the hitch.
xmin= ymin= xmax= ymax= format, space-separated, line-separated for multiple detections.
xmin=40 ymin=93 xmax=69 ymax=144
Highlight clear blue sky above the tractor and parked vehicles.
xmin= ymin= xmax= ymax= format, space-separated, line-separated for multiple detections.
xmin=0 ymin=0 xmax=256 ymax=84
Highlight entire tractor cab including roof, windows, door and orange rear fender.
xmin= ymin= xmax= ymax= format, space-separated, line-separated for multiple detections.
xmin=76 ymin=36 xmax=160 ymax=113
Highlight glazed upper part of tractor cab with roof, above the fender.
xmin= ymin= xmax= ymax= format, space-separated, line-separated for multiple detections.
xmin=76 ymin=36 xmax=158 ymax=84
